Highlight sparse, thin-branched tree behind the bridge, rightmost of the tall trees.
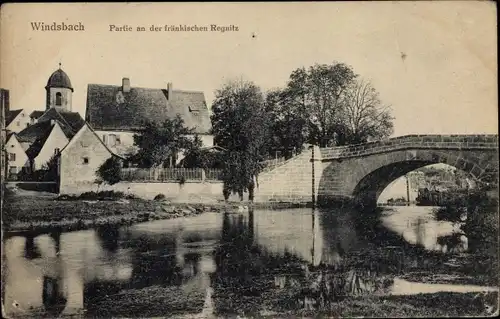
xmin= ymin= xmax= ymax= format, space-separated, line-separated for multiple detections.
xmin=337 ymin=79 xmax=394 ymax=145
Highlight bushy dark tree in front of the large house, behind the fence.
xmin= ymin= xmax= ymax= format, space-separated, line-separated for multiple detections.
xmin=133 ymin=115 xmax=193 ymax=167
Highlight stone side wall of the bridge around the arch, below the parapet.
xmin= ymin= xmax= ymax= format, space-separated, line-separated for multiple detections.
xmin=318 ymin=148 xmax=498 ymax=206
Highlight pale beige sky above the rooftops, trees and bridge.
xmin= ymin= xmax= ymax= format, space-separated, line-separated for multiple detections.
xmin=0 ymin=1 xmax=498 ymax=136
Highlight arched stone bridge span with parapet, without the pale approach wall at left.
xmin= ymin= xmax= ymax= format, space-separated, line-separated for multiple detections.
xmin=318 ymin=138 xmax=498 ymax=205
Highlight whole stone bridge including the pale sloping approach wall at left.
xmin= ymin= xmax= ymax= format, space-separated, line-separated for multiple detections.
xmin=257 ymin=135 xmax=498 ymax=208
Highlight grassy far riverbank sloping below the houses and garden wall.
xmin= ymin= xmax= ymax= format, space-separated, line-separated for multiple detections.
xmin=2 ymin=193 xmax=308 ymax=235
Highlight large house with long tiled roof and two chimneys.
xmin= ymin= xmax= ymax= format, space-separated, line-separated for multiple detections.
xmin=85 ymin=78 xmax=213 ymax=160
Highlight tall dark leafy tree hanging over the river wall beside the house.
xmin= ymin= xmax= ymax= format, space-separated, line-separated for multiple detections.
xmin=211 ymin=80 xmax=269 ymax=199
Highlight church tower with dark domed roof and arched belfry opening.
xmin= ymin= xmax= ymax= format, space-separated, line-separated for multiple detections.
xmin=45 ymin=63 xmax=73 ymax=112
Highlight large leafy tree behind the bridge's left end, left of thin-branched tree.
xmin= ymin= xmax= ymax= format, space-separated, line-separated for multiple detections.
xmin=283 ymin=62 xmax=357 ymax=147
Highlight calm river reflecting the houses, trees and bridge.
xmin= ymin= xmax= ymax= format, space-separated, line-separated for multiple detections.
xmin=2 ymin=206 xmax=494 ymax=317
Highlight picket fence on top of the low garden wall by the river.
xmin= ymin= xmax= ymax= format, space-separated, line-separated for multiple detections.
xmin=121 ymin=168 xmax=222 ymax=182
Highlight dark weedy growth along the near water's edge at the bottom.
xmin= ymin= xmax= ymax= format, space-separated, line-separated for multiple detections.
xmin=84 ymin=286 xmax=498 ymax=318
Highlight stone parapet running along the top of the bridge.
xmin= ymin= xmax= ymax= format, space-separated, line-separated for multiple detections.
xmin=321 ymin=134 xmax=498 ymax=161
